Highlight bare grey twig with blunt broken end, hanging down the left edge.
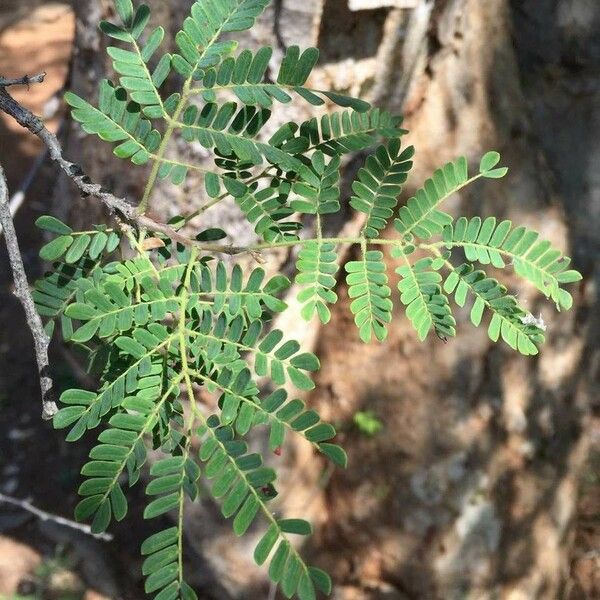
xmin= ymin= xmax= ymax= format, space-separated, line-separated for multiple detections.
xmin=0 ymin=166 xmax=58 ymax=420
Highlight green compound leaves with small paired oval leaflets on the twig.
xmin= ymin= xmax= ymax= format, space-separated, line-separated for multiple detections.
xmin=34 ymin=0 xmax=580 ymax=600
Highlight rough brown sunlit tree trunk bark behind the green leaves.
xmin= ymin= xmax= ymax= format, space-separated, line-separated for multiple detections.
xmin=57 ymin=0 xmax=600 ymax=600
